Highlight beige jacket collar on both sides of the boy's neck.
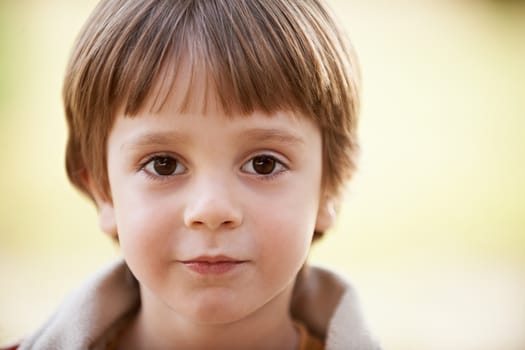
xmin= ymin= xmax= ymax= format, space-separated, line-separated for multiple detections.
xmin=15 ymin=260 xmax=380 ymax=350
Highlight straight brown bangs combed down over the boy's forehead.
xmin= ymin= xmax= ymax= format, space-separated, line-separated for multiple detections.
xmin=106 ymin=0 xmax=354 ymax=116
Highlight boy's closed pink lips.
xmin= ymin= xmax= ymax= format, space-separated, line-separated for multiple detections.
xmin=179 ymin=255 xmax=248 ymax=275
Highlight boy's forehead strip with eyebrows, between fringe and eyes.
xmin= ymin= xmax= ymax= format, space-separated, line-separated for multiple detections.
xmin=113 ymin=93 xmax=322 ymax=152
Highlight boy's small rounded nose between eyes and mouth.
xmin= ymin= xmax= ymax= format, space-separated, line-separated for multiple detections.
xmin=184 ymin=179 xmax=242 ymax=231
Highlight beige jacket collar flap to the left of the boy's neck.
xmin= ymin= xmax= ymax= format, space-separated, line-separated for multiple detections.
xmin=12 ymin=260 xmax=140 ymax=350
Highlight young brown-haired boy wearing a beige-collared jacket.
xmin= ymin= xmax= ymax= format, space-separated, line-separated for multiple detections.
xmin=10 ymin=0 xmax=378 ymax=350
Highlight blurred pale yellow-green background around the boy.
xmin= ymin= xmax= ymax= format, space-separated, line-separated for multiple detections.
xmin=0 ymin=0 xmax=525 ymax=350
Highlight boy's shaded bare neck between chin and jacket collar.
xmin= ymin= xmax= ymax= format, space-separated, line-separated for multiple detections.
xmin=120 ymin=287 xmax=299 ymax=350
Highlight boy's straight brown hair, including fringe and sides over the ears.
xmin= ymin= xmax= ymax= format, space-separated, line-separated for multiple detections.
xmin=63 ymin=0 xmax=359 ymax=206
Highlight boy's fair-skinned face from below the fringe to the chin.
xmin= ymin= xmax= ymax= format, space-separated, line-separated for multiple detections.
xmin=101 ymin=80 xmax=329 ymax=323
